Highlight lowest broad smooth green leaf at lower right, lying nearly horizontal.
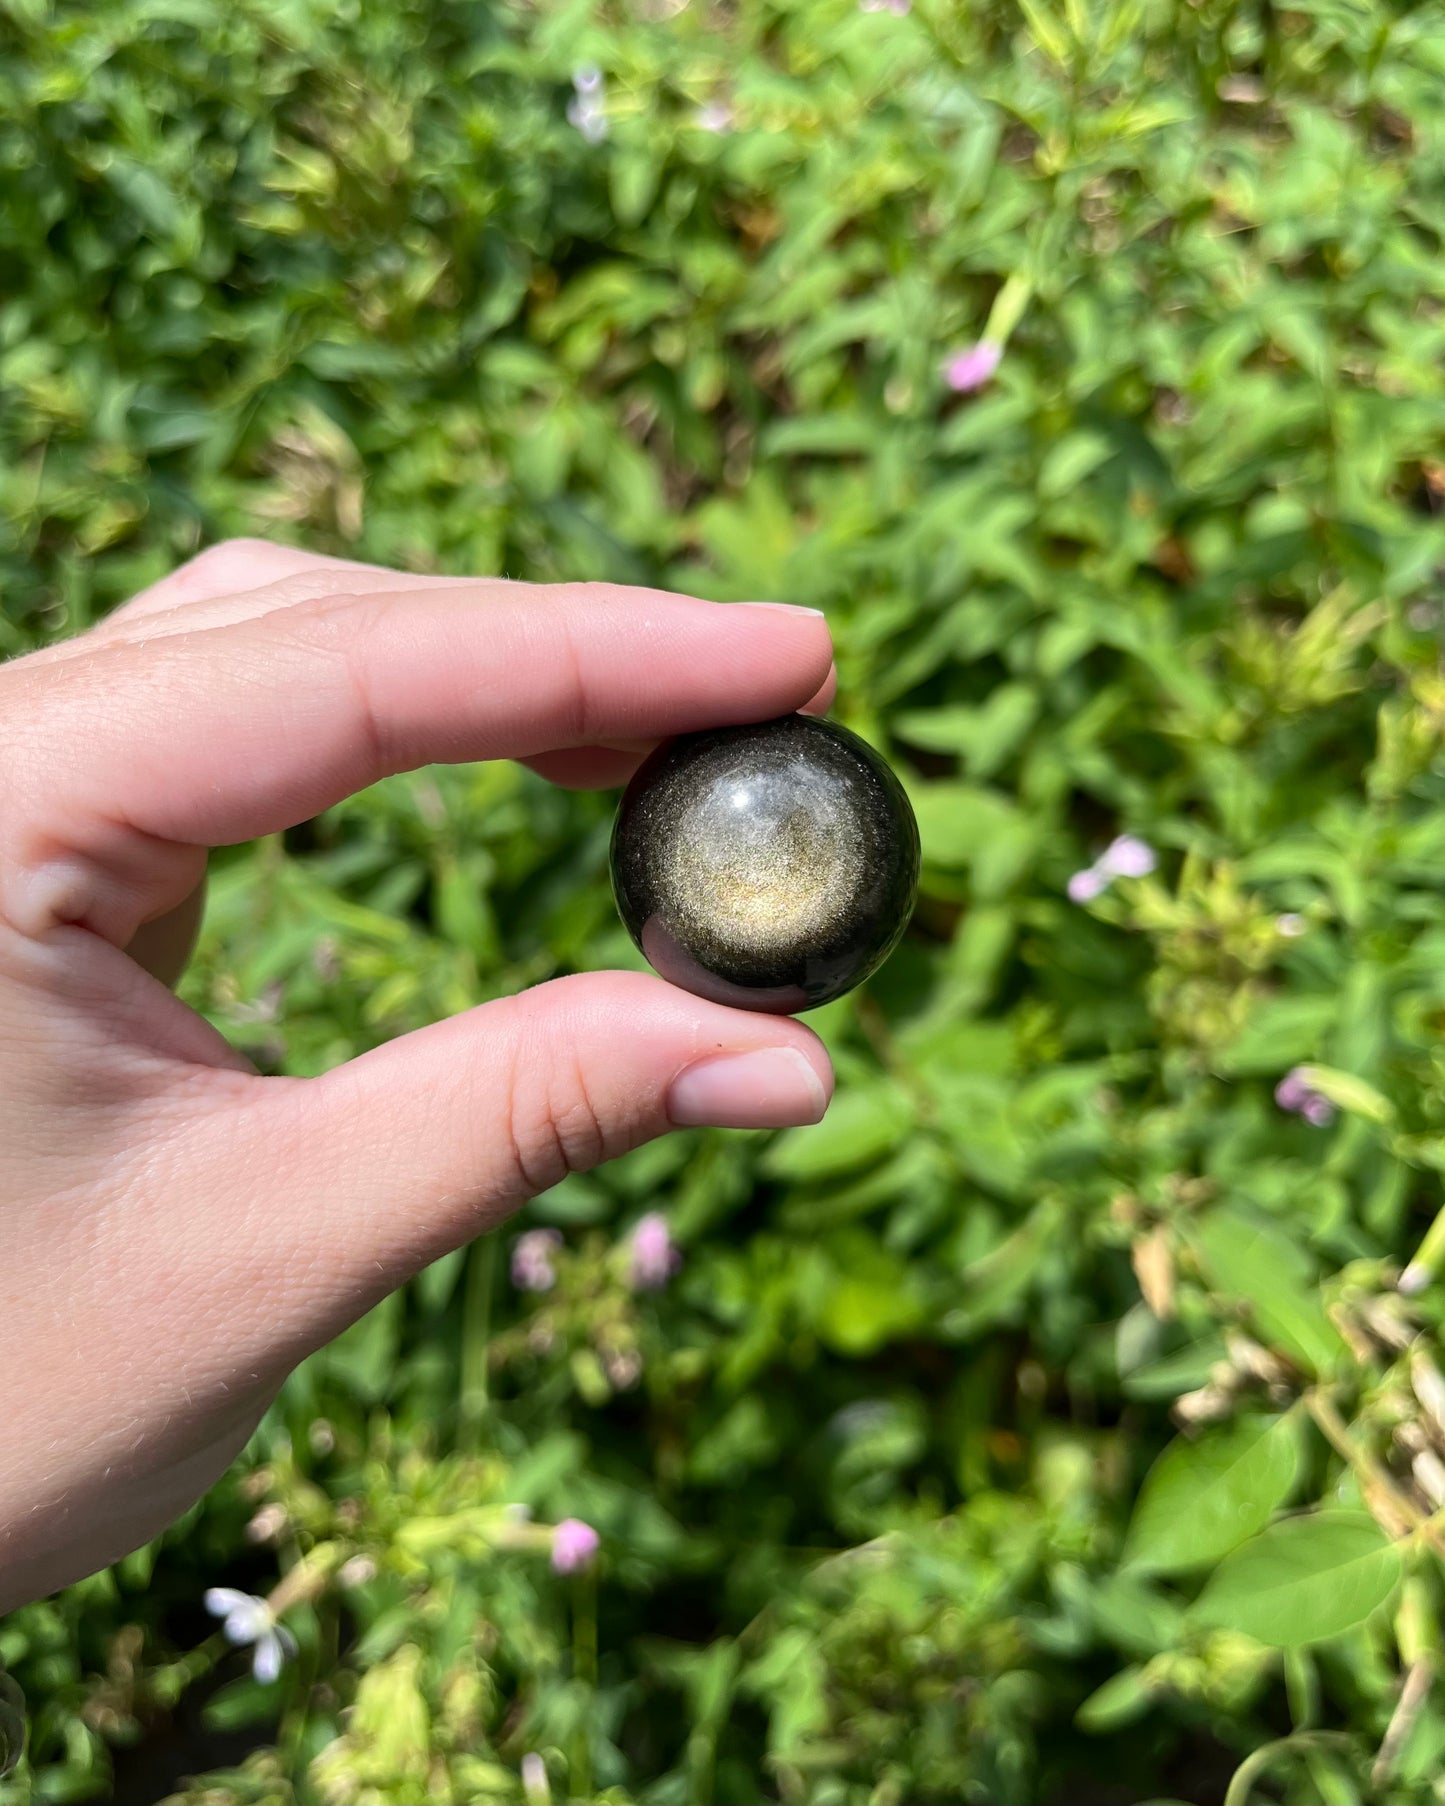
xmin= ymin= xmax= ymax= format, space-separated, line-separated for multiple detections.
xmin=1192 ymin=1510 xmax=1402 ymax=1649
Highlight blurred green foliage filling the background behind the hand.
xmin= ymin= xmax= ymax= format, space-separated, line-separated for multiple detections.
xmin=0 ymin=0 xmax=1445 ymax=1806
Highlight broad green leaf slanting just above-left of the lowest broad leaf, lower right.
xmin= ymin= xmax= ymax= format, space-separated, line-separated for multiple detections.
xmin=1123 ymin=1412 xmax=1301 ymax=1573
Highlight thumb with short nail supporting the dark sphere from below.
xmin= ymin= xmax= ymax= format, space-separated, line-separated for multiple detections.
xmin=213 ymin=972 xmax=833 ymax=1355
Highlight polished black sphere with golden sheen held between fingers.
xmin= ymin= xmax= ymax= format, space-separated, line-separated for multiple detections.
xmin=612 ymin=715 xmax=918 ymax=1015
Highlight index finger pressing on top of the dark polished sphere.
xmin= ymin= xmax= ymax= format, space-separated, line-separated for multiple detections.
xmin=0 ymin=580 xmax=831 ymax=945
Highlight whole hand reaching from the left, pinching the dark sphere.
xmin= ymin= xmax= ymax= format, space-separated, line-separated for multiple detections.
xmin=0 ymin=542 xmax=833 ymax=1611
